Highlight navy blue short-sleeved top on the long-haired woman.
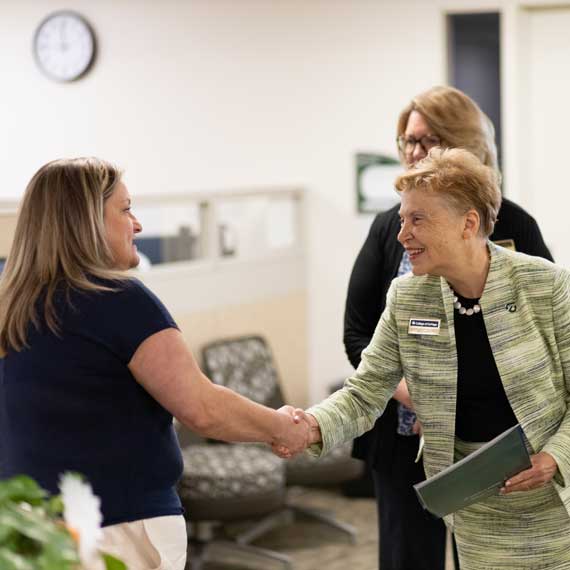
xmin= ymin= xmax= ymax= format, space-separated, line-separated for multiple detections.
xmin=0 ymin=279 xmax=182 ymax=525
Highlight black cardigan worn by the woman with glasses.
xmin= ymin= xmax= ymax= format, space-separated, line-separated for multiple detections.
xmin=344 ymin=198 xmax=552 ymax=466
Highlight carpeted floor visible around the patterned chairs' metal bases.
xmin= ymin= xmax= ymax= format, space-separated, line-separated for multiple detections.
xmin=191 ymin=489 xmax=378 ymax=570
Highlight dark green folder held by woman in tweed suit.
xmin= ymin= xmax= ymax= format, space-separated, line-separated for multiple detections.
xmin=414 ymin=424 xmax=531 ymax=518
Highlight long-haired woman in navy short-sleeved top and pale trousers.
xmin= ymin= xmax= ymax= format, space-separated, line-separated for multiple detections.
xmin=0 ymin=158 xmax=307 ymax=570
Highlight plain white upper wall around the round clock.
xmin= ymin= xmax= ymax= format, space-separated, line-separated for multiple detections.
xmin=0 ymin=0 xmax=562 ymax=398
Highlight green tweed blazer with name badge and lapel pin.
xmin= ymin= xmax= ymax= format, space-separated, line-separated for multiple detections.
xmin=308 ymin=242 xmax=570 ymax=513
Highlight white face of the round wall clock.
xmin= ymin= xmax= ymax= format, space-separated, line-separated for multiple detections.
xmin=34 ymin=11 xmax=95 ymax=81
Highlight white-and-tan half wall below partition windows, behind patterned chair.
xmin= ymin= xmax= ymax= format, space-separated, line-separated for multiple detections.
xmin=138 ymin=248 xmax=310 ymax=405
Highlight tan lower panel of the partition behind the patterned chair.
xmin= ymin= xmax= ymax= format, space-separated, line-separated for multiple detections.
xmin=174 ymin=292 xmax=308 ymax=406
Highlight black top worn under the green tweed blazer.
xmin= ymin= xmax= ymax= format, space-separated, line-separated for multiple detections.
xmin=453 ymin=293 xmax=517 ymax=441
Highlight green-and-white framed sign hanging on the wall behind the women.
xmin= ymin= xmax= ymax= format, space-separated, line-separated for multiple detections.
xmin=355 ymin=153 xmax=404 ymax=213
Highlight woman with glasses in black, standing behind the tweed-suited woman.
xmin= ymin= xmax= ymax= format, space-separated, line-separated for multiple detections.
xmin=344 ymin=87 xmax=552 ymax=570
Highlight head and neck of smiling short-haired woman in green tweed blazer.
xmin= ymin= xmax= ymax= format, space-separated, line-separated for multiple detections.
xmin=396 ymin=148 xmax=501 ymax=298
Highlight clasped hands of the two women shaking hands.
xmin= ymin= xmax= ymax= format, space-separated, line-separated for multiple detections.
xmin=271 ymin=406 xmax=321 ymax=459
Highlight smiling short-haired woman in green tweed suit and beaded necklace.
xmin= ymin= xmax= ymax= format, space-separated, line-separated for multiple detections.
xmin=290 ymin=148 xmax=570 ymax=570
